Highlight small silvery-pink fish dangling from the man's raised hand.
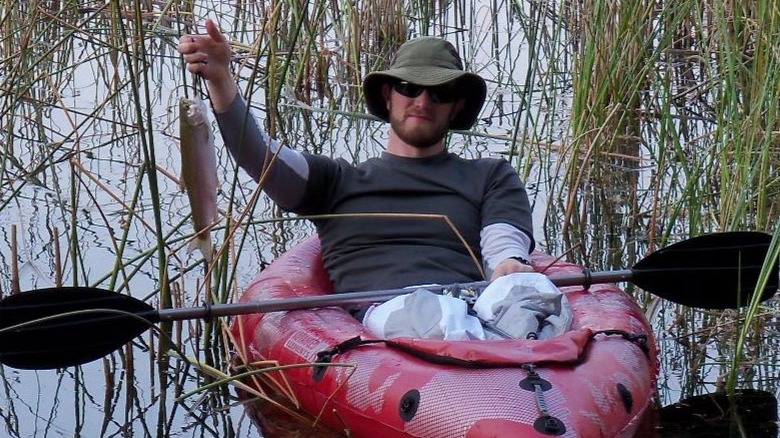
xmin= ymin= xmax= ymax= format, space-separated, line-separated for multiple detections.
xmin=179 ymin=97 xmax=217 ymax=263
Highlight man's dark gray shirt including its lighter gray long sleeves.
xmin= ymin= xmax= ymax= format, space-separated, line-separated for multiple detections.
xmin=217 ymin=94 xmax=534 ymax=292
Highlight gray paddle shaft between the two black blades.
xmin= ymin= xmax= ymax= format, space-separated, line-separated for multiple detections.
xmin=158 ymin=269 xmax=632 ymax=321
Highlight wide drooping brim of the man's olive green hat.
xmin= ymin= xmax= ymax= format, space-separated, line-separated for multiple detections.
xmin=363 ymin=66 xmax=487 ymax=130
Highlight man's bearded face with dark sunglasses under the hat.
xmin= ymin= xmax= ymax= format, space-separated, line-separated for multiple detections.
xmin=383 ymin=83 xmax=463 ymax=149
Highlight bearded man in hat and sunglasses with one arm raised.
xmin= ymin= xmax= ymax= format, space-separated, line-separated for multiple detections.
xmin=178 ymin=20 xmax=534 ymax=298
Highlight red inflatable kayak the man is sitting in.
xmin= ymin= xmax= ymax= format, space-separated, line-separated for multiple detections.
xmin=231 ymin=238 xmax=658 ymax=438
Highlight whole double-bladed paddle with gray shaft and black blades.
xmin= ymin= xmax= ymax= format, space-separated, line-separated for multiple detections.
xmin=0 ymin=232 xmax=778 ymax=369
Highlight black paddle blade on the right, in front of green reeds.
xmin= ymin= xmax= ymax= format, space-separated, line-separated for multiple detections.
xmin=631 ymin=231 xmax=778 ymax=309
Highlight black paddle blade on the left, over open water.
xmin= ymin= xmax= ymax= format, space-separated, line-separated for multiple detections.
xmin=0 ymin=287 xmax=158 ymax=369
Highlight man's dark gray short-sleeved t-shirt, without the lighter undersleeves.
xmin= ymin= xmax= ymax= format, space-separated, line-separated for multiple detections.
xmin=302 ymin=152 xmax=531 ymax=291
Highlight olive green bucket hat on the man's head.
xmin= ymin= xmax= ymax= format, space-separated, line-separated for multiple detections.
xmin=363 ymin=37 xmax=487 ymax=130
